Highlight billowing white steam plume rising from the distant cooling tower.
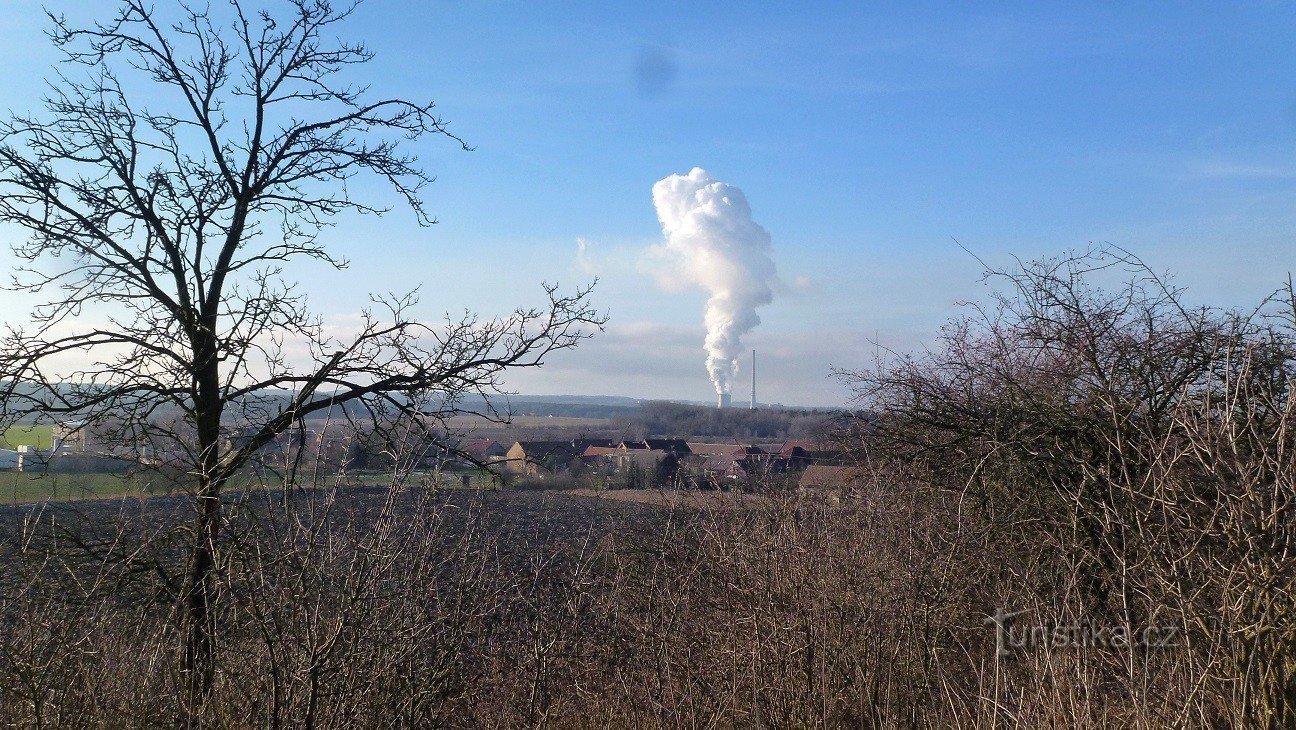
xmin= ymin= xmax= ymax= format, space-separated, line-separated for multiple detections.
xmin=652 ymin=167 xmax=779 ymax=393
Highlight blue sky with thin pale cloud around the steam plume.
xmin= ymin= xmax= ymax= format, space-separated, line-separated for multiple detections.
xmin=0 ymin=0 xmax=1296 ymax=405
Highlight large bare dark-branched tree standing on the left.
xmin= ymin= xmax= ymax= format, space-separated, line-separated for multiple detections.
xmin=0 ymin=0 xmax=603 ymax=701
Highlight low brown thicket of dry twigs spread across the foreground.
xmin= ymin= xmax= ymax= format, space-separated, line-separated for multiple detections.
xmin=0 ymin=474 xmax=986 ymax=727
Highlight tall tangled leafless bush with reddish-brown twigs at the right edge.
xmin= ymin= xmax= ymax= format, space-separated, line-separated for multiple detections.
xmin=848 ymin=249 xmax=1296 ymax=727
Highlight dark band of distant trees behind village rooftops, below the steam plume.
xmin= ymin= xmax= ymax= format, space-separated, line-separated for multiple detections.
xmin=612 ymin=401 xmax=845 ymax=440
